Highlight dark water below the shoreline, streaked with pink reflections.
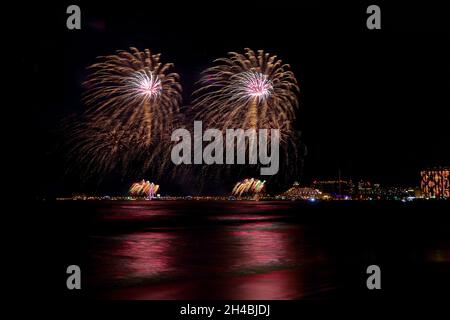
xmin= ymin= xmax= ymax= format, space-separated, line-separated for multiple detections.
xmin=34 ymin=201 xmax=450 ymax=299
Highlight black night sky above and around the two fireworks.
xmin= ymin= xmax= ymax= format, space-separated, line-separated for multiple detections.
xmin=24 ymin=1 xmax=450 ymax=195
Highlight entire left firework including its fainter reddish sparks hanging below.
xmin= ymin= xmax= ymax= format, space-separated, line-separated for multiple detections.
xmin=66 ymin=48 xmax=181 ymax=179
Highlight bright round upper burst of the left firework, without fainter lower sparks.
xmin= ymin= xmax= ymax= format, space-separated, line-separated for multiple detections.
xmin=83 ymin=48 xmax=181 ymax=146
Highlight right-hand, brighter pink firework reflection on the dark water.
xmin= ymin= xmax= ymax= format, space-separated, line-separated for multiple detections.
xmin=221 ymin=222 xmax=302 ymax=300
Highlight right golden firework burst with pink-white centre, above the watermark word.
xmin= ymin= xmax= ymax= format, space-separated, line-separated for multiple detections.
xmin=194 ymin=49 xmax=299 ymax=132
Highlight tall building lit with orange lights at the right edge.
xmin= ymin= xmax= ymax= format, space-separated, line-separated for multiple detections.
xmin=420 ymin=167 xmax=450 ymax=199
